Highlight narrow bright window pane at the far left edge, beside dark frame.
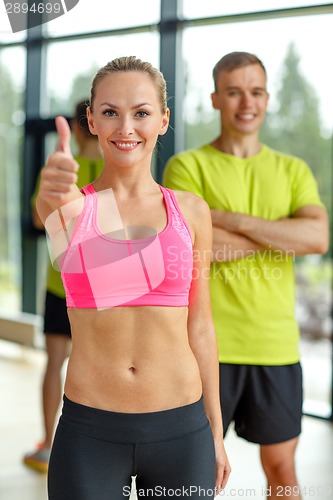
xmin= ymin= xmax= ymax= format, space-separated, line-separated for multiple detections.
xmin=0 ymin=47 xmax=25 ymax=312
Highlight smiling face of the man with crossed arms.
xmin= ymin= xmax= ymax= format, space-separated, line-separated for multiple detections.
xmin=212 ymin=64 xmax=269 ymax=136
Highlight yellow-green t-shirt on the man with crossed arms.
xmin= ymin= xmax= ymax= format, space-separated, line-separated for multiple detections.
xmin=163 ymin=145 xmax=322 ymax=365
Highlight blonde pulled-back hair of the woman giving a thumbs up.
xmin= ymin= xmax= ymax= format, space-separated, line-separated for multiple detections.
xmin=90 ymin=56 xmax=167 ymax=113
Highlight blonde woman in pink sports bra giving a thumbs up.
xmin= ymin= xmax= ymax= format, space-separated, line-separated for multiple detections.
xmin=37 ymin=57 xmax=230 ymax=500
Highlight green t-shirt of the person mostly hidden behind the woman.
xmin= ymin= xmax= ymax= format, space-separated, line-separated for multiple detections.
xmin=31 ymin=156 xmax=104 ymax=298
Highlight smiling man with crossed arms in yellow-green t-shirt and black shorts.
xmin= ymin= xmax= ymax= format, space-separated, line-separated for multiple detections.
xmin=164 ymin=52 xmax=328 ymax=499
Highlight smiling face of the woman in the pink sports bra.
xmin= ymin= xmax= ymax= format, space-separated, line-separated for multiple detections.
xmin=88 ymin=71 xmax=169 ymax=166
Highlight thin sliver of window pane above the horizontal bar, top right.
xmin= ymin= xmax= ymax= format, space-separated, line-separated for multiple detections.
xmin=183 ymin=0 xmax=331 ymax=19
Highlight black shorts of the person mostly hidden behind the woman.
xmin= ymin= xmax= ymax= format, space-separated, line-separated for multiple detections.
xmin=44 ymin=292 xmax=71 ymax=338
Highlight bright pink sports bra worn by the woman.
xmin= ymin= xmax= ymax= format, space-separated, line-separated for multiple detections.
xmin=60 ymin=184 xmax=193 ymax=309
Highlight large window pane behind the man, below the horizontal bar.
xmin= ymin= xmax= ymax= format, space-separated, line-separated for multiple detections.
xmin=183 ymin=14 xmax=333 ymax=416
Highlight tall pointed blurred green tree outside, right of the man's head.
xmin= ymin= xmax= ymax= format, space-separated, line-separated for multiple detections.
xmin=261 ymin=43 xmax=332 ymax=216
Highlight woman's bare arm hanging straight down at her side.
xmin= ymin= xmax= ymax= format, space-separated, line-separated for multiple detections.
xmin=176 ymin=193 xmax=231 ymax=491
